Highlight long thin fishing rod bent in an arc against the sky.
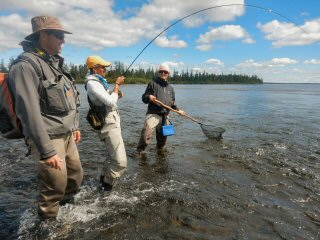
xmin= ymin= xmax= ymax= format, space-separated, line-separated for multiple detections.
xmin=123 ymin=3 xmax=308 ymax=75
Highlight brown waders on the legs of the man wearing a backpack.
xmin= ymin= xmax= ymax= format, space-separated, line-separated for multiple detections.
xmin=28 ymin=134 xmax=83 ymax=218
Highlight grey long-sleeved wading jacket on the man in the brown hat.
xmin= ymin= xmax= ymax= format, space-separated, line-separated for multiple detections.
xmin=9 ymin=41 xmax=80 ymax=159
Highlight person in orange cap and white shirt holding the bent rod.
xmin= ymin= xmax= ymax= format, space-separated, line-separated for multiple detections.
xmin=86 ymin=56 xmax=127 ymax=191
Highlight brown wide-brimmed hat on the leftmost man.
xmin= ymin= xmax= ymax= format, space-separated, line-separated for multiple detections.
xmin=25 ymin=16 xmax=72 ymax=41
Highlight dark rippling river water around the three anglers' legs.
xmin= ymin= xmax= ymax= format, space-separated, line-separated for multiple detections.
xmin=0 ymin=84 xmax=320 ymax=240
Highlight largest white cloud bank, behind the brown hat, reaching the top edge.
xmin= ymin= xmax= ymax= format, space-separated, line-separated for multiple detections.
xmin=0 ymin=0 xmax=245 ymax=51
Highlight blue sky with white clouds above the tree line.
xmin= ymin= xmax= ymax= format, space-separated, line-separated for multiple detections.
xmin=0 ymin=0 xmax=320 ymax=83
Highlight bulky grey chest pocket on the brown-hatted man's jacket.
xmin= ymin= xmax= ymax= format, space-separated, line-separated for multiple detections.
xmin=42 ymin=75 xmax=76 ymax=114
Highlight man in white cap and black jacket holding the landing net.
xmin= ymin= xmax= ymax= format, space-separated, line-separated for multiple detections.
xmin=137 ymin=63 xmax=185 ymax=156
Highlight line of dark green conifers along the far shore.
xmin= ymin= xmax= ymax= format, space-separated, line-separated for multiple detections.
xmin=0 ymin=59 xmax=263 ymax=84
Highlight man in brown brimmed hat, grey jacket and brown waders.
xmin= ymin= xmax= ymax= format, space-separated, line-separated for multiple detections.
xmin=9 ymin=16 xmax=83 ymax=218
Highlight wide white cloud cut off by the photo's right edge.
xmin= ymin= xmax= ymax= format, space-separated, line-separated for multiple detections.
xmin=257 ymin=18 xmax=320 ymax=47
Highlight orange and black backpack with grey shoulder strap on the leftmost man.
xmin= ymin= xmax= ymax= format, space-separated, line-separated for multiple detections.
xmin=0 ymin=53 xmax=42 ymax=139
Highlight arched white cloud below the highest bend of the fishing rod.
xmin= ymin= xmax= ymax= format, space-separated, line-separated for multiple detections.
xmin=196 ymin=25 xmax=255 ymax=51
